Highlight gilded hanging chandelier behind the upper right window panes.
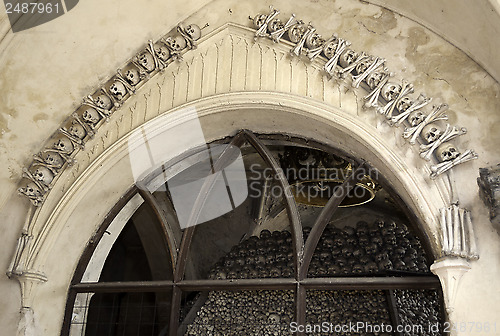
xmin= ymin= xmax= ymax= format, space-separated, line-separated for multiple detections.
xmin=279 ymin=147 xmax=380 ymax=207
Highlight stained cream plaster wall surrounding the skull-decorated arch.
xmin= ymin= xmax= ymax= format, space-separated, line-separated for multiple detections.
xmin=0 ymin=0 xmax=500 ymax=335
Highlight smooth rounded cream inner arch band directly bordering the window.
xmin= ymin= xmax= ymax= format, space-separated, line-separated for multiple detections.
xmin=9 ymin=92 xmax=447 ymax=334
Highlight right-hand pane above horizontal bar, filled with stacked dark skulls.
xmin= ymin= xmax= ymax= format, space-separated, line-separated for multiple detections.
xmin=308 ymin=217 xmax=429 ymax=277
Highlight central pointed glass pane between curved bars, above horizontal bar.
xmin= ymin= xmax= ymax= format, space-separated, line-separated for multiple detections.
xmin=185 ymin=146 xmax=294 ymax=279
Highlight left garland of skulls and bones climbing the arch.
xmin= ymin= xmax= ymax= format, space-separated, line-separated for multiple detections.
xmin=18 ymin=23 xmax=202 ymax=206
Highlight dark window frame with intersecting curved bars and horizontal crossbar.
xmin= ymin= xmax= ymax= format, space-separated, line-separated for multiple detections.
xmin=61 ymin=130 xmax=445 ymax=336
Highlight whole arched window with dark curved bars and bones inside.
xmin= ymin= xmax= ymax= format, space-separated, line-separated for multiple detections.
xmin=62 ymin=130 xmax=445 ymax=335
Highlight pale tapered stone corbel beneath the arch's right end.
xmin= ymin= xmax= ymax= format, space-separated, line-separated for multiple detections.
xmin=431 ymin=257 xmax=471 ymax=314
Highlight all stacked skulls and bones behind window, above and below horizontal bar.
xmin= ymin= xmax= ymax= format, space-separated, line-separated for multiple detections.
xmin=184 ymin=219 xmax=440 ymax=335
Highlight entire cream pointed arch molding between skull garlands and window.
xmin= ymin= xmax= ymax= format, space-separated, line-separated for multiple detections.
xmin=9 ymin=15 xmax=473 ymax=328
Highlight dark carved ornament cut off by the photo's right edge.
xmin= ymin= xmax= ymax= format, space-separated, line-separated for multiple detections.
xmin=477 ymin=163 xmax=500 ymax=228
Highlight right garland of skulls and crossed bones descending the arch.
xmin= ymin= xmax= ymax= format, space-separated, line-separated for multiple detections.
xmin=250 ymin=7 xmax=477 ymax=178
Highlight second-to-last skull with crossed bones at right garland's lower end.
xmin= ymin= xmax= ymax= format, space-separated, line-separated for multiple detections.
xmin=420 ymin=124 xmax=467 ymax=161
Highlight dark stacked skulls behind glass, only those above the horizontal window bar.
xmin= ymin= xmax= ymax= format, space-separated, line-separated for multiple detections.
xmin=208 ymin=219 xmax=429 ymax=280
